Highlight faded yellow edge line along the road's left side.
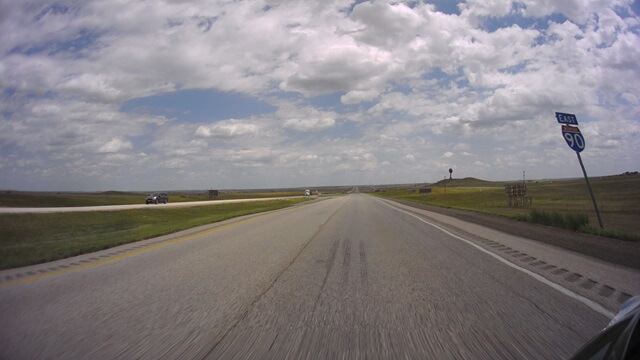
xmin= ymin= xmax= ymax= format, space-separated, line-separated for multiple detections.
xmin=0 ymin=213 xmax=272 ymax=288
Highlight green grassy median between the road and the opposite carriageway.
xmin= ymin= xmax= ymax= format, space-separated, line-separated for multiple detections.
xmin=0 ymin=198 xmax=306 ymax=269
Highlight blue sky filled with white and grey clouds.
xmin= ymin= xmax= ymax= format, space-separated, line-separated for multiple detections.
xmin=0 ymin=0 xmax=640 ymax=191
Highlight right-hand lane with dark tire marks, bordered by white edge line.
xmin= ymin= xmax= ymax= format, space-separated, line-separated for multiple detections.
xmin=208 ymin=196 xmax=608 ymax=359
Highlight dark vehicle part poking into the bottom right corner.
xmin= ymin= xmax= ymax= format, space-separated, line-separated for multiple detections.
xmin=571 ymin=295 xmax=640 ymax=360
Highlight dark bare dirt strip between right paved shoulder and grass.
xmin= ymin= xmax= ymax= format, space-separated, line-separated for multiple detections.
xmin=393 ymin=199 xmax=640 ymax=269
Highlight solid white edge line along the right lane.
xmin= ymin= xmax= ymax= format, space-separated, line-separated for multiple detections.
xmin=379 ymin=200 xmax=615 ymax=319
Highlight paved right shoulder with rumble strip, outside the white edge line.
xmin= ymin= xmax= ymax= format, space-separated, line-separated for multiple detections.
xmin=381 ymin=199 xmax=640 ymax=313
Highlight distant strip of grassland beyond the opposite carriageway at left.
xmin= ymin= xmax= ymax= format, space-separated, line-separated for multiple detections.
xmin=0 ymin=191 xmax=303 ymax=207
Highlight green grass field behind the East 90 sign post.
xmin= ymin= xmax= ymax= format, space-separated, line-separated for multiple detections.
xmin=375 ymin=175 xmax=640 ymax=239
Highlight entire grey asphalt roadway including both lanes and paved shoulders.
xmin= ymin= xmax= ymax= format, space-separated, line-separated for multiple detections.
xmin=0 ymin=195 xmax=640 ymax=359
